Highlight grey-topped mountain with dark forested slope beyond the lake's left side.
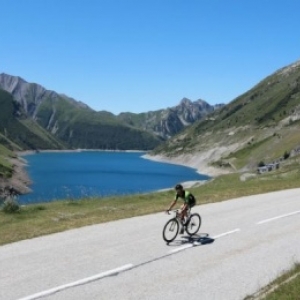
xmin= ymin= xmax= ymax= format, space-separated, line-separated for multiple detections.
xmin=0 ymin=73 xmax=161 ymax=150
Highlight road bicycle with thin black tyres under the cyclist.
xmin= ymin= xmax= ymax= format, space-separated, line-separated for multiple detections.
xmin=163 ymin=209 xmax=201 ymax=243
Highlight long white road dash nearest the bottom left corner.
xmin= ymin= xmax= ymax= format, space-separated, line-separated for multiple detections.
xmin=18 ymin=264 xmax=133 ymax=300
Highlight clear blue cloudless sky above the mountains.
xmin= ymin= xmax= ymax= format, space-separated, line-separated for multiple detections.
xmin=0 ymin=0 xmax=300 ymax=114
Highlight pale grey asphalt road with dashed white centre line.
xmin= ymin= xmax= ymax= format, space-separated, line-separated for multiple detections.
xmin=0 ymin=189 xmax=300 ymax=300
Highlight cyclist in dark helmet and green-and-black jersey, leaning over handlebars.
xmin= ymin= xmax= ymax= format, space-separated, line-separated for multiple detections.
xmin=167 ymin=184 xmax=196 ymax=233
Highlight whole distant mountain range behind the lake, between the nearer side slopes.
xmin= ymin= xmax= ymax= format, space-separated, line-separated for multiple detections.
xmin=0 ymin=73 xmax=220 ymax=150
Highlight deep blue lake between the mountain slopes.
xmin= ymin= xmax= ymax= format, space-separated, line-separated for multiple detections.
xmin=20 ymin=151 xmax=210 ymax=204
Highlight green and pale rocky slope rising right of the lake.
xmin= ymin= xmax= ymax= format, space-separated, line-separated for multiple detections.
xmin=152 ymin=61 xmax=300 ymax=171
